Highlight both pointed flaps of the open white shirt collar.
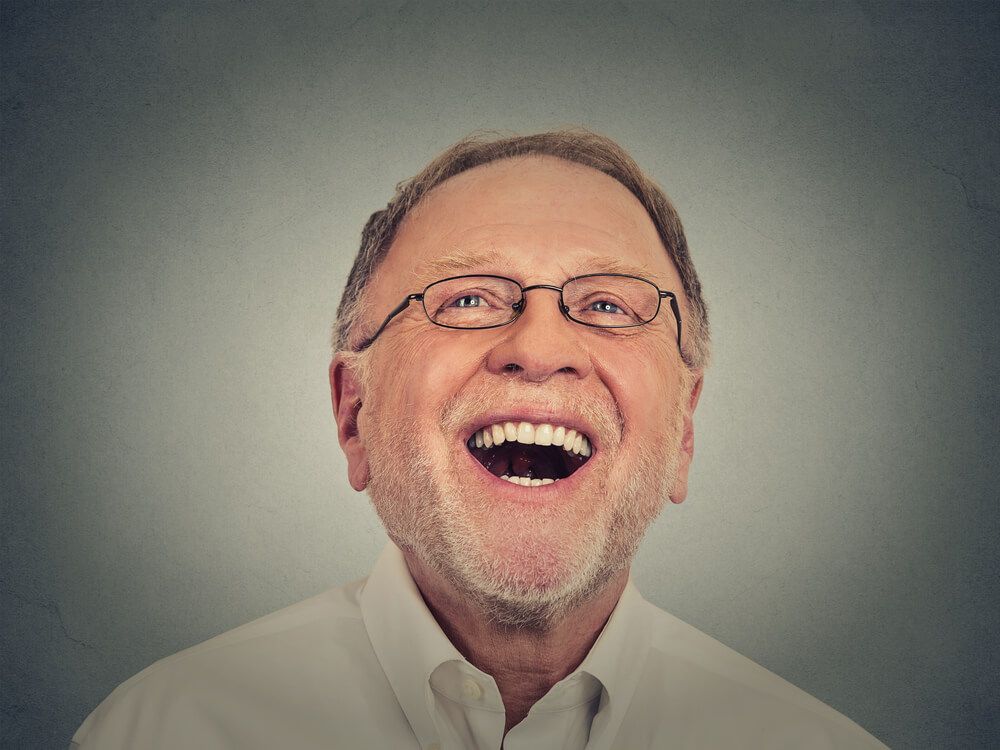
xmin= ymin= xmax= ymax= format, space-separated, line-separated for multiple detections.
xmin=361 ymin=542 xmax=650 ymax=748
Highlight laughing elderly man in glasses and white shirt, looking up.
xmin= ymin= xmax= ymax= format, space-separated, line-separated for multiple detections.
xmin=74 ymin=131 xmax=883 ymax=750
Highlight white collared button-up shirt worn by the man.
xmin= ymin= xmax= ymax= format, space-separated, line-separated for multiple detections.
xmin=73 ymin=544 xmax=884 ymax=750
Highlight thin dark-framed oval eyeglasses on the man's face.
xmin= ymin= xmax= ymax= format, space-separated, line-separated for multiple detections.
xmin=354 ymin=273 xmax=681 ymax=352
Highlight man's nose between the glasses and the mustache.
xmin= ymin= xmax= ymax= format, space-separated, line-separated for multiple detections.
xmin=487 ymin=286 xmax=593 ymax=383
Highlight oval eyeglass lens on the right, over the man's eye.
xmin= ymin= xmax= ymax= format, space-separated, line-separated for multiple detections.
xmin=563 ymin=276 xmax=660 ymax=328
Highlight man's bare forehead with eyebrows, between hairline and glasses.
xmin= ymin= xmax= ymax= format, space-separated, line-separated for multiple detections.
xmin=376 ymin=156 xmax=680 ymax=302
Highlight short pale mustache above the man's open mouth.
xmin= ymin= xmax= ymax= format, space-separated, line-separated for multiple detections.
xmin=440 ymin=381 xmax=625 ymax=447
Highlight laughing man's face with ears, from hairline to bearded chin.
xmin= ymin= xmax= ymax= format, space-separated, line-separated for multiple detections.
xmin=331 ymin=157 xmax=698 ymax=622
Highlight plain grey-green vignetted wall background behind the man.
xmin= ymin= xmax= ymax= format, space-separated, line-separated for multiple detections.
xmin=0 ymin=0 xmax=1000 ymax=748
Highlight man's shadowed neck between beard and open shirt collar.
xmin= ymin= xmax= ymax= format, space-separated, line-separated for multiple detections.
xmin=403 ymin=551 xmax=628 ymax=734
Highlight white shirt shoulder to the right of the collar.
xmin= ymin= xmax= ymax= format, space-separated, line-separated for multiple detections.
xmin=625 ymin=601 xmax=884 ymax=748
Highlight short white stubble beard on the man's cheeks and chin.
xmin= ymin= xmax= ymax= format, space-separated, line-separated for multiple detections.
xmin=366 ymin=384 xmax=684 ymax=630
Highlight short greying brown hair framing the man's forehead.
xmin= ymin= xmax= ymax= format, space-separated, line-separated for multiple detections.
xmin=333 ymin=129 xmax=710 ymax=369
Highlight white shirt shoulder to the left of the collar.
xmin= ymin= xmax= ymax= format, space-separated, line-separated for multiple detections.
xmin=73 ymin=581 xmax=410 ymax=748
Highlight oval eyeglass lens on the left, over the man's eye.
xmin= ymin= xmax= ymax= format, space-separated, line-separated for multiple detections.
xmin=424 ymin=276 xmax=521 ymax=328
